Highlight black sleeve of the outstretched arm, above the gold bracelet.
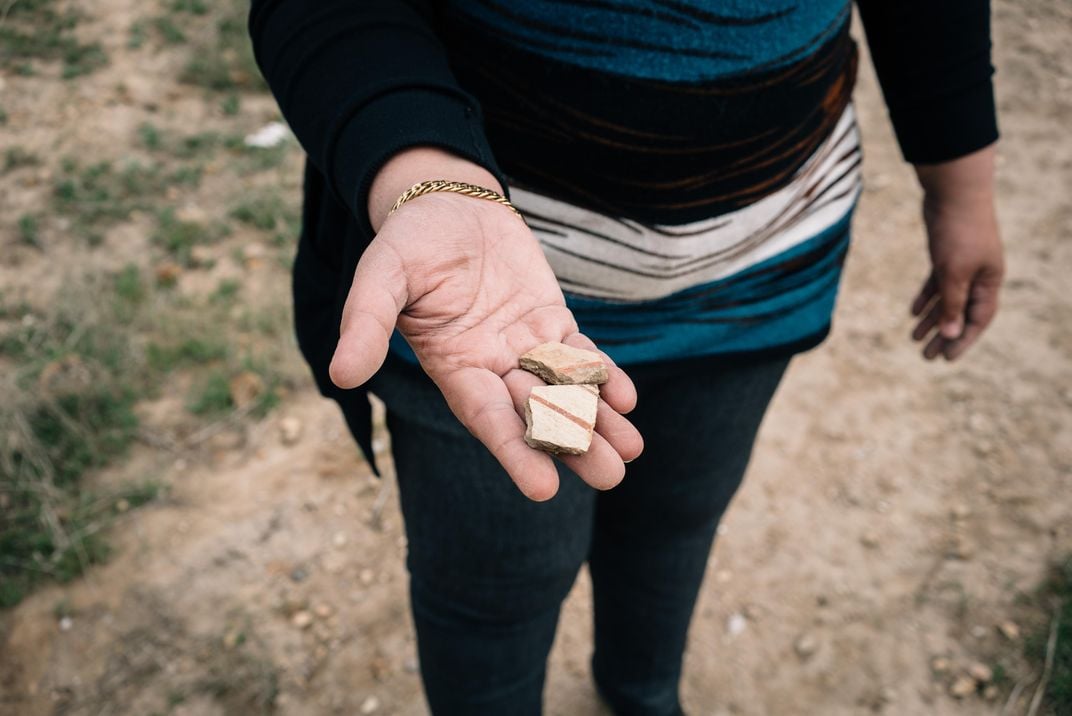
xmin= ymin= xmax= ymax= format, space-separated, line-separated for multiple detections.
xmin=250 ymin=0 xmax=506 ymax=234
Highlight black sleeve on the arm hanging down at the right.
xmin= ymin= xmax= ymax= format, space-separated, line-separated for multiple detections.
xmin=857 ymin=0 xmax=998 ymax=164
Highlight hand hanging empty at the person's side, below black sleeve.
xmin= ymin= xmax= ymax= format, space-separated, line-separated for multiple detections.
xmin=912 ymin=145 xmax=1004 ymax=360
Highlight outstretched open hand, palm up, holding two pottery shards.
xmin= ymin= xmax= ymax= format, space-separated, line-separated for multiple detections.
xmin=330 ymin=148 xmax=643 ymax=501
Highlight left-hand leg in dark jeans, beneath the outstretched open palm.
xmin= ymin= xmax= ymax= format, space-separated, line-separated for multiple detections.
xmin=373 ymin=367 xmax=595 ymax=716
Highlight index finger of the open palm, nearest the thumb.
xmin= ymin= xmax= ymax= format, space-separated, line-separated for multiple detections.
xmin=440 ymin=368 xmax=561 ymax=502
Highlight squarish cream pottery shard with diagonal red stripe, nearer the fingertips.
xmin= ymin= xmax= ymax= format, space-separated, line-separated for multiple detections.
xmin=525 ymin=385 xmax=599 ymax=454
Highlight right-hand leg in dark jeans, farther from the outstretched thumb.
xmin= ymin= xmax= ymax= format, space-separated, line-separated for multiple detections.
xmin=590 ymin=359 xmax=788 ymax=716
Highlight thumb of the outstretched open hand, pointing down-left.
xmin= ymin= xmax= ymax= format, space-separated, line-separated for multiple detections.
xmin=328 ymin=240 xmax=406 ymax=388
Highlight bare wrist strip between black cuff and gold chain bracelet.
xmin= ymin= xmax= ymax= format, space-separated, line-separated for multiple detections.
xmin=368 ymin=147 xmax=503 ymax=232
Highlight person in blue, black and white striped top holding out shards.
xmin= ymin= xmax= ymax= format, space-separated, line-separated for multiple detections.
xmin=250 ymin=0 xmax=1002 ymax=716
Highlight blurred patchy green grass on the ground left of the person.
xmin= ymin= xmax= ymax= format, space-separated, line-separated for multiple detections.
xmin=0 ymin=0 xmax=301 ymax=608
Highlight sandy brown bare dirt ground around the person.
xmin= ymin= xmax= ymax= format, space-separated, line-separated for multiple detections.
xmin=0 ymin=0 xmax=1072 ymax=716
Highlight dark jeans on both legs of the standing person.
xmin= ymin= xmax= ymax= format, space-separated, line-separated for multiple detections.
xmin=372 ymin=358 xmax=789 ymax=716
